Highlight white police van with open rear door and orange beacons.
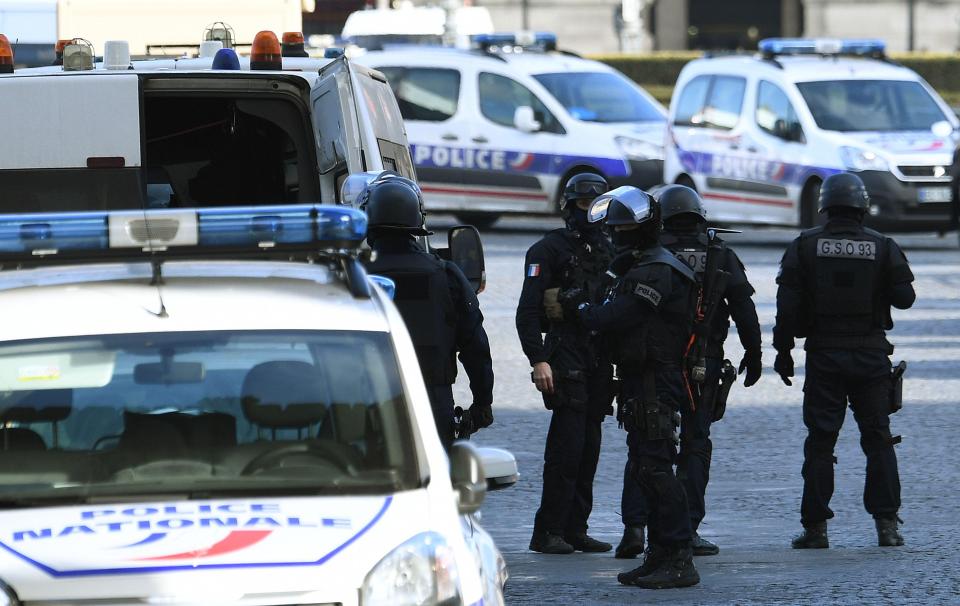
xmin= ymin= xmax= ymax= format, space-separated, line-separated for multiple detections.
xmin=0 ymin=32 xmax=415 ymax=212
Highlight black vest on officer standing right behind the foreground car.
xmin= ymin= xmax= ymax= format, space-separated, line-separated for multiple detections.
xmin=367 ymin=251 xmax=457 ymax=385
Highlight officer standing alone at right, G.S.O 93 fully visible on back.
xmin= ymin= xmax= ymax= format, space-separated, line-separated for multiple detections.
xmin=773 ymin=173 xmax=916 ymax=549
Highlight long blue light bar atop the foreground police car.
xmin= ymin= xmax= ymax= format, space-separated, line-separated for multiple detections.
xmin=0 ymin=204 xmax=367 ymax=257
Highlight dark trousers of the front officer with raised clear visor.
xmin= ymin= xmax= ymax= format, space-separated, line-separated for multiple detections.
xmin=620 ymin=370 xmax=692 ymax=546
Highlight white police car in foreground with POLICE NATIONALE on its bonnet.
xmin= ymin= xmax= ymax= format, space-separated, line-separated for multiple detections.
xmin=0 ymin=204 xmax=517 ymax=606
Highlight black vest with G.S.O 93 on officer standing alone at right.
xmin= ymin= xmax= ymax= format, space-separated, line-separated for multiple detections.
xmin=799 ymin=223 xmax=890 ymax=340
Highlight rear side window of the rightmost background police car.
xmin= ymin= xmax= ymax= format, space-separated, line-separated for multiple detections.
xmin=674 ymin=76 xmax=747 ymax=130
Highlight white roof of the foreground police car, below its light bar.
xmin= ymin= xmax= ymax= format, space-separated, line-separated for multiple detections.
xmin=0 ymin=261 xmax=390 ymax=341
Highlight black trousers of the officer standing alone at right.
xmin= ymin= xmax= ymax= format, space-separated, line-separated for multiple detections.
xmin=800 ymin=350 xmax=900 ymax=525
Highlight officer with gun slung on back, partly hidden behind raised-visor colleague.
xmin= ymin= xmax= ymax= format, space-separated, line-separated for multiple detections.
xmin=617 ymin=185 xmax=763 ymax=557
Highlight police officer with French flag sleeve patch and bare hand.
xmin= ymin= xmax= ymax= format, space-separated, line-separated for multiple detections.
xmin=516 ymin=173 xmax=613 ymax=554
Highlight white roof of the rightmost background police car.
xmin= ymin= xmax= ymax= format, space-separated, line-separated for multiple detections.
xmin=690 ymin=55 xmax=920 ymax=82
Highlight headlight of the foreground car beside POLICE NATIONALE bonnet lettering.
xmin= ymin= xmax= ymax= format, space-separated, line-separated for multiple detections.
xmin=360 ymin=532 xmax=462 ymax=606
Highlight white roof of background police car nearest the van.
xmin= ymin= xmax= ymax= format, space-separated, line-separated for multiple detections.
xmin=355 ymin=45 xmax=613 ymax=74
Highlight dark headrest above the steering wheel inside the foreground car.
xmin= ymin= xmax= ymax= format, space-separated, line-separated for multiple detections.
xmin=240 ymin=360 xmax=330 ymax=429
